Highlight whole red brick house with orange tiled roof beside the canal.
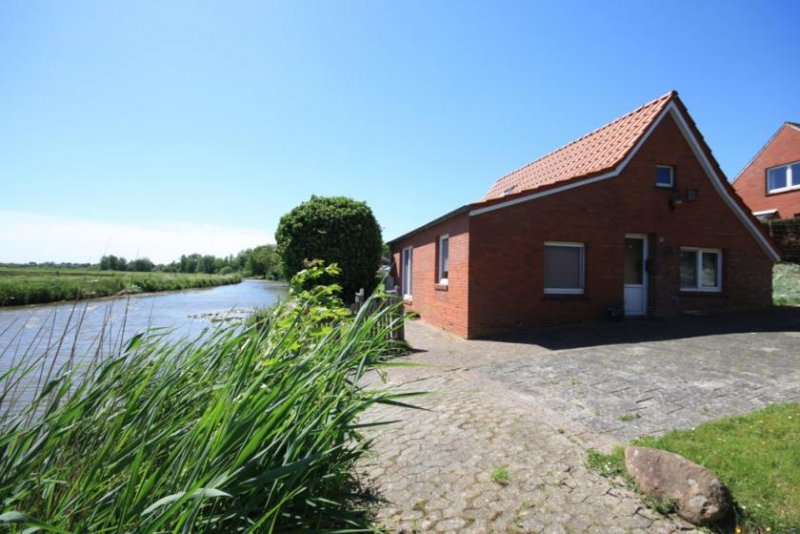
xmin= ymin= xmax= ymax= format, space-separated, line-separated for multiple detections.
xmin=390 ymin=92 xmax=778 ymax=337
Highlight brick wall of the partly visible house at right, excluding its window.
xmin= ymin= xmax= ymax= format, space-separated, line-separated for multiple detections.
xmin=733 ymin=123 xmax=800 ymax=219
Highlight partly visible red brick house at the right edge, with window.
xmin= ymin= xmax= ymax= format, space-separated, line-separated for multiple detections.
xmin=733 ymin=122 xmax=800 ymax=219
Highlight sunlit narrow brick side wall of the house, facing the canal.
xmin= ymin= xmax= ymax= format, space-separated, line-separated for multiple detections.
xmin=392 ymin=213 xmax=470 ymax=337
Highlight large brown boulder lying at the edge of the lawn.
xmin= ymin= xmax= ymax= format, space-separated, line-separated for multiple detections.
xmin=625 ymin=447 xmax=732 ymax=525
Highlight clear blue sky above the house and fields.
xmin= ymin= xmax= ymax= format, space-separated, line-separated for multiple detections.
xmin=0 ymin=0 xmax=800 ymax=261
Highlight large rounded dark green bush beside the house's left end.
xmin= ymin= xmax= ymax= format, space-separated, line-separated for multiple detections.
xmin=275 ymin=196 xmax=383 ymax=302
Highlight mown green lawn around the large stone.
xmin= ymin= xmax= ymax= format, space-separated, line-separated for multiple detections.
xmin=587 ymin=403 xmax=800 ymax=532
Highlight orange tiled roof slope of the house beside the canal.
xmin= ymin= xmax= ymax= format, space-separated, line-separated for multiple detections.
xmin=483 ymin=91 xmax=678 ymax=201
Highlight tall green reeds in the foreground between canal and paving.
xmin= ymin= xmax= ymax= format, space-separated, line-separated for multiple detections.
xmin=0 ymin=266 xmax=407 ymax=533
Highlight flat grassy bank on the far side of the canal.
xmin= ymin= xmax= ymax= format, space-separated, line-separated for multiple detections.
xmin=0 ymin=267 xmax=242 ymax=306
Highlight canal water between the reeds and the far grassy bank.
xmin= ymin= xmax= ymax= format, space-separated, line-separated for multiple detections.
xmin=0 ymin=280 xmax=287 ymax=411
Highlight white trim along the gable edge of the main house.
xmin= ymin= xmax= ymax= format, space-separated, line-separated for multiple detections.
xmin=469 ymin=102 xmax=780 ymax=261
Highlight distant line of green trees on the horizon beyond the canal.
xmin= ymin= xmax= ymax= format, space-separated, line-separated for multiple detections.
xmin=96 ymin=245 xmax=282 ymax=280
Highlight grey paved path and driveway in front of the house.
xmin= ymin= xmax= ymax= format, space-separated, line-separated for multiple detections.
xmin=361 ymin=310 xmax=800 ymax=533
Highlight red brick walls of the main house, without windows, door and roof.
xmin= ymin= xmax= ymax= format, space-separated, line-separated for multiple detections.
xmin=392 ymin=97 xmax=773 ymax=337
